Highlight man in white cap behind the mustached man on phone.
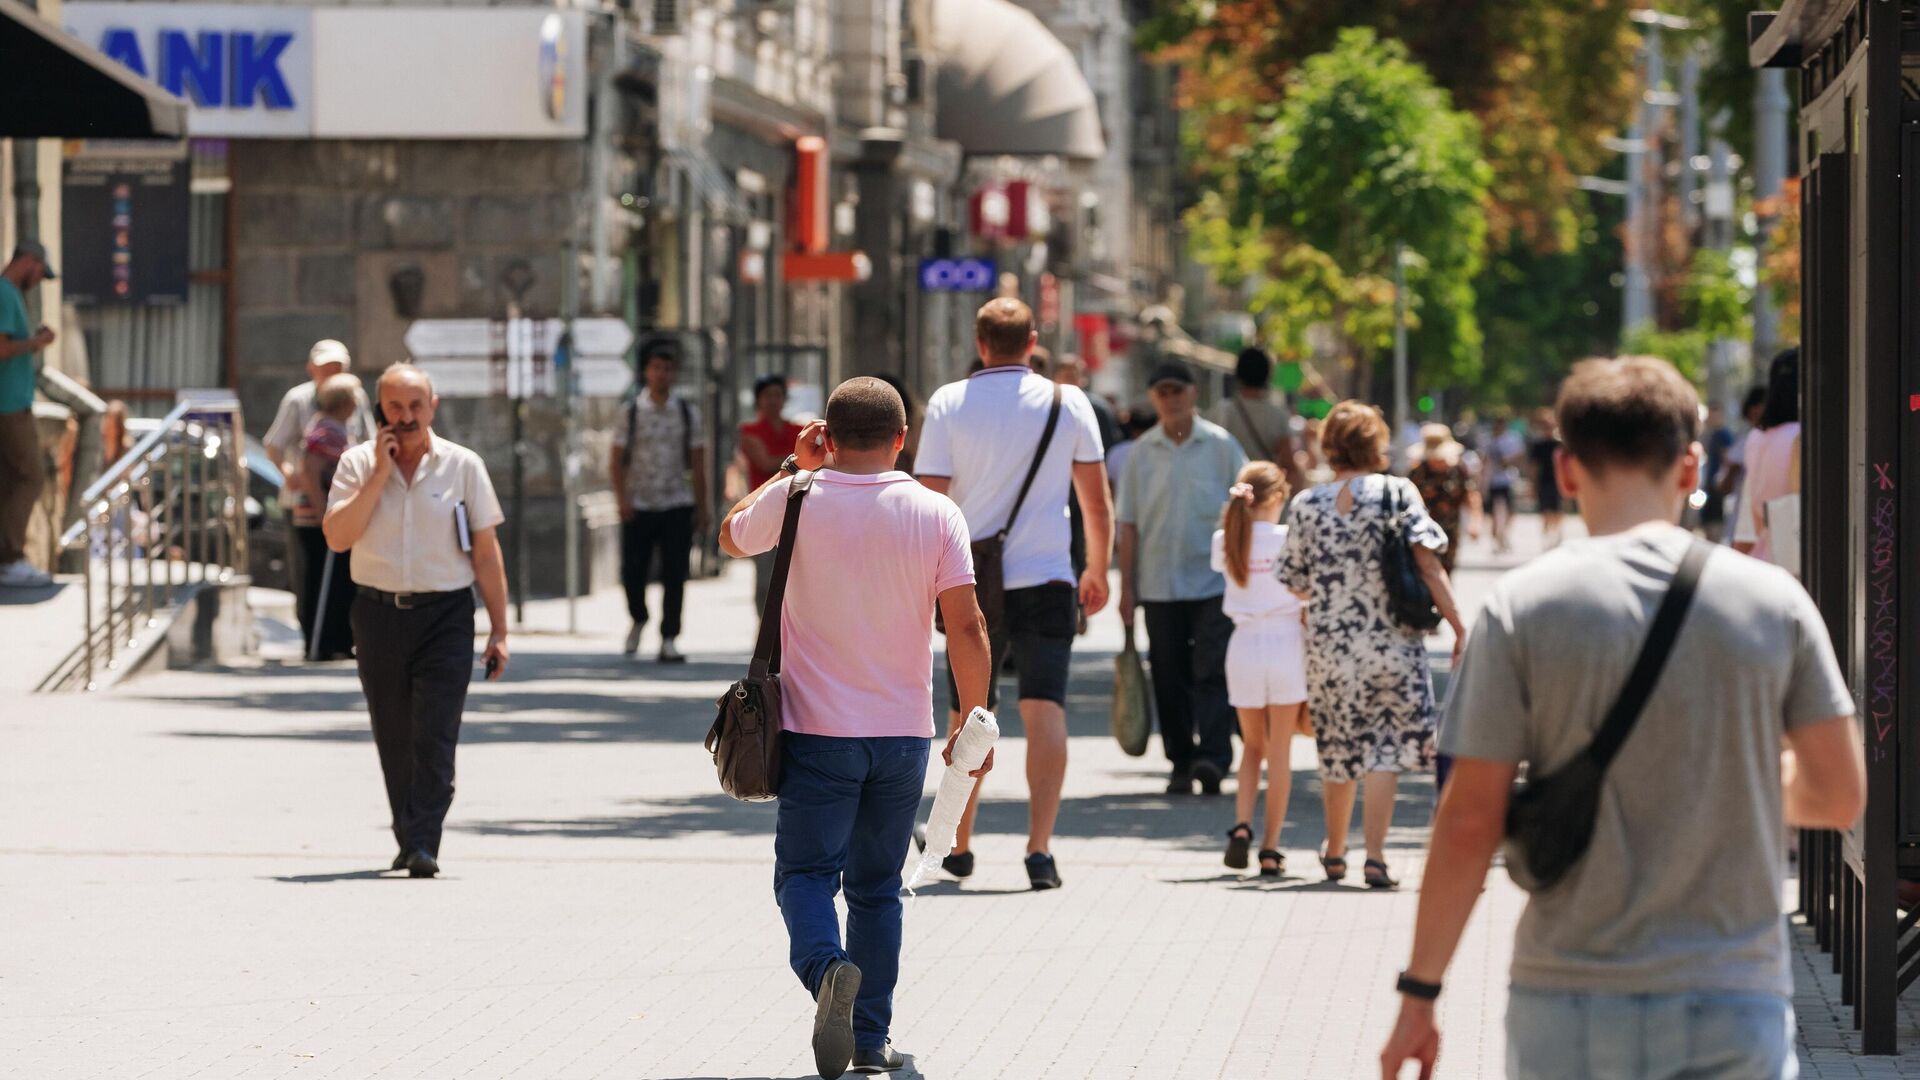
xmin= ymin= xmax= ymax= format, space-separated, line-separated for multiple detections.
xmin=261 ymin=338 xmax=372 ymax=659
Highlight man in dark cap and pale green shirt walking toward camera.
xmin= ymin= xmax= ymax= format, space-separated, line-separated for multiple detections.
xmin=1119 ymin=361 xmax=1246 ymax=796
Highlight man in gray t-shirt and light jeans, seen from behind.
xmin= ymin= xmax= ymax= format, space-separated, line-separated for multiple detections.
xmin=1382 ymin=359 xmax=1864 ymax=1080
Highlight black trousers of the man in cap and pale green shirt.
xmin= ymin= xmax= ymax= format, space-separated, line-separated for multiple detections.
xmin=1140 ymin=596 xmax=1235 ymax=773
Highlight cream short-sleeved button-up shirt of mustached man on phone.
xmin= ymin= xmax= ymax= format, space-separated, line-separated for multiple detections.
xmin=326 ymin=432 xmax=507 ymax=592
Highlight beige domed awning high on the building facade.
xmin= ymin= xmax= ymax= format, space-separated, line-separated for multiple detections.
xmin=933 ymin=0 xmax=1106 ymax=161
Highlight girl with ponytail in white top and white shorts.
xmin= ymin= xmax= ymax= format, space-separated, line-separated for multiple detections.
xmin=1213 ymin=461 xmax=1308 ymax=878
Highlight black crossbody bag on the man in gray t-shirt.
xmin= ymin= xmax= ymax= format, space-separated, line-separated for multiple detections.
xmin=1505 ymin=540 xmax=1713 ymax=892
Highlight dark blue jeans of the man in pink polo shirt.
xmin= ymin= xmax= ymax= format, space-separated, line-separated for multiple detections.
xmin=774 ymin=732 xmax=929 ymax=1049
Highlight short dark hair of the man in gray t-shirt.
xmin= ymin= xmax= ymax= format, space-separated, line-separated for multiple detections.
xmin=1555 ymin=356 xmax=1699 ymax=477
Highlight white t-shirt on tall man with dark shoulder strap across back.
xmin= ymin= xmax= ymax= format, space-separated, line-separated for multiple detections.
xmin=914 ymin=365 xmax=1106 ymax=588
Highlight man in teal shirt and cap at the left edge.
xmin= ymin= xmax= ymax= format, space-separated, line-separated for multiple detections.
xmin=0 ymin=242 xmax=56 ymax=588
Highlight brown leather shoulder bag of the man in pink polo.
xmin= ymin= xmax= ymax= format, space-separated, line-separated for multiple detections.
xmin=707 ymin=473 xmax=814 ymax=803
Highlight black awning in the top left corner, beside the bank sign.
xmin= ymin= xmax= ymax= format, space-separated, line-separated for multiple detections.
xmin=0 ymin=0 xmax=186 ymax=138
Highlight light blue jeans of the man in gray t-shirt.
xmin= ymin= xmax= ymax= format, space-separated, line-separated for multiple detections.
xmin=1507 ymin=986 xmax=1799 ymax=1080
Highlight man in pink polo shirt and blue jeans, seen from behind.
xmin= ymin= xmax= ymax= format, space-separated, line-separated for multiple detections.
xmin=720 ymin=379 xmax=993 ymax=1080
